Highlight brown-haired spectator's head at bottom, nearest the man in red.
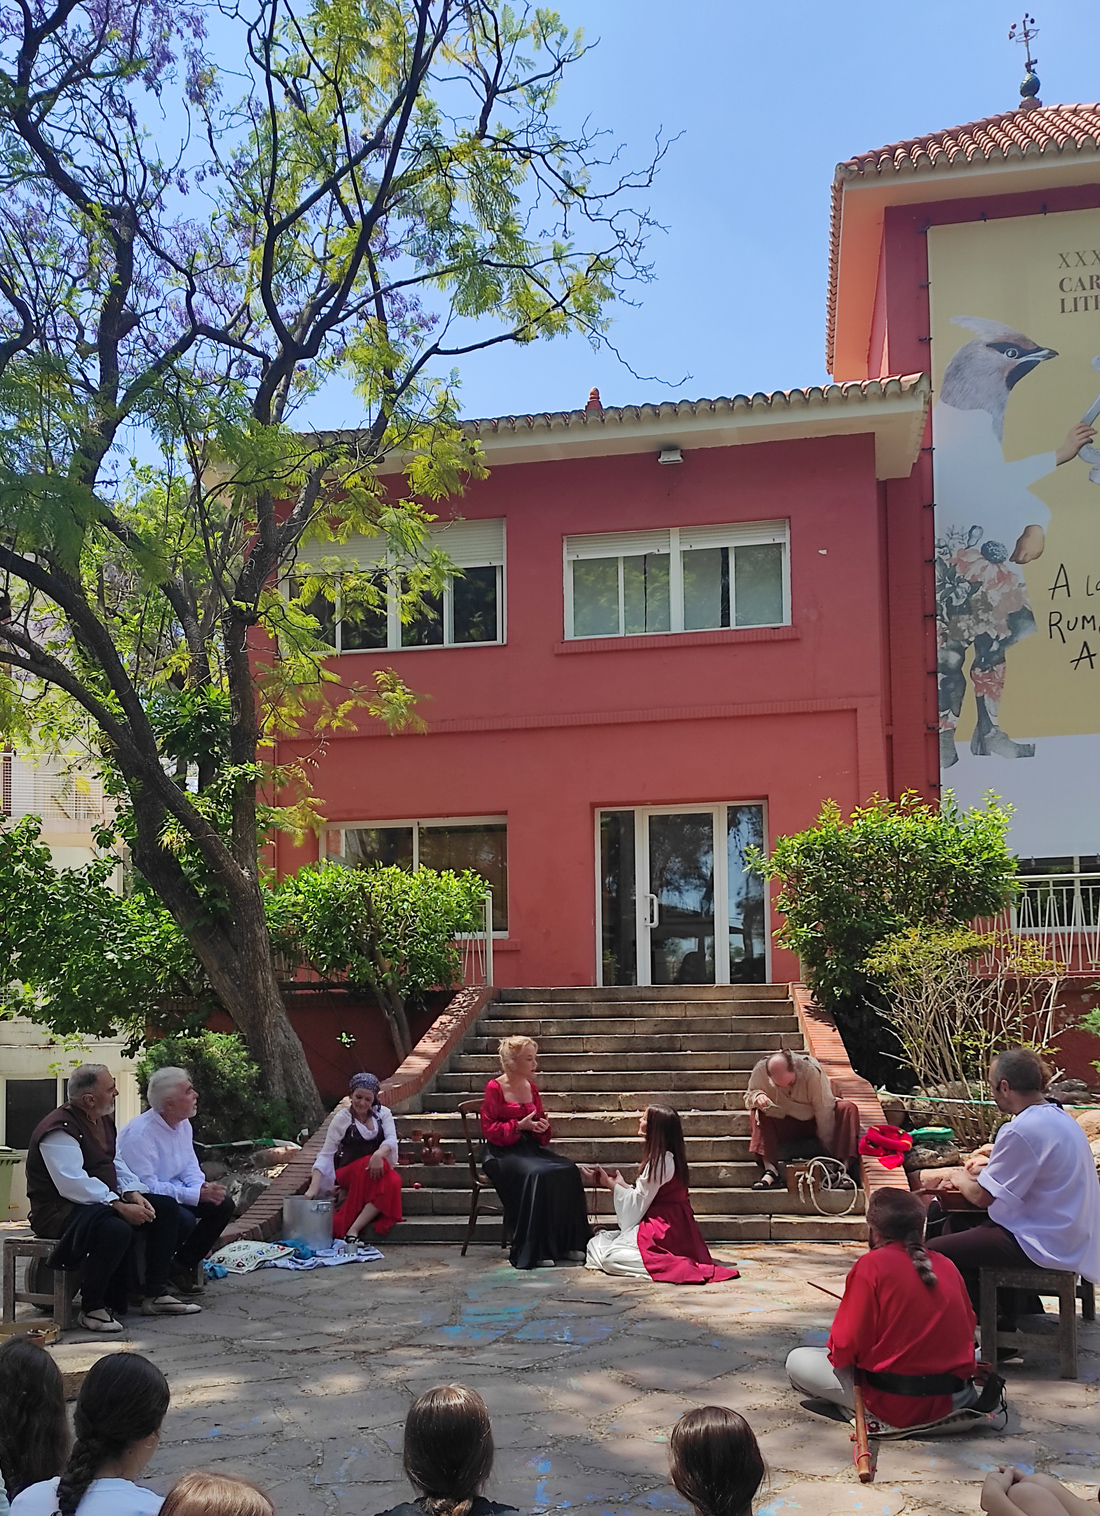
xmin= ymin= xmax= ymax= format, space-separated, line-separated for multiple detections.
xmin=668 ymin=1405 xmax=768 ymax=1516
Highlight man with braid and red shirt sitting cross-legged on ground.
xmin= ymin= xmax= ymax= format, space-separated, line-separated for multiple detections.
xmin=786 ymin=1190 xmax=1002 ymax=1434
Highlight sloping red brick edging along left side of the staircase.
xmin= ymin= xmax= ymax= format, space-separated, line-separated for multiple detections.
xmin=221 ymin=988 xmax=495 ymax=1243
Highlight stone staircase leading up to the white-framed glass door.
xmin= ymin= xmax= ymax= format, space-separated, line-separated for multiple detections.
xmin=389 ymin=984 xmax=865 ymax=1245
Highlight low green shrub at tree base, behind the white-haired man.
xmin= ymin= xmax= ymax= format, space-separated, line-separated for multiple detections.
xmin=138 ymin=1031 xmax=295 ymax=1143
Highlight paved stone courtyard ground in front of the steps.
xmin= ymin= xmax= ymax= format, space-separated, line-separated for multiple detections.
xmin=38 ymin=1243 xmax=1100 ymax=1516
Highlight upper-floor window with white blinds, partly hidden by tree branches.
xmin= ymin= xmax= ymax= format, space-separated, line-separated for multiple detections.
xmin=295 ymin=518 xmax=505 ymax=653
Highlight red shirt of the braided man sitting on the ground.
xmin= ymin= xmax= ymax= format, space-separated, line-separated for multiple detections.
xmin=829 ymin=1242 xmax=976 ymax=1427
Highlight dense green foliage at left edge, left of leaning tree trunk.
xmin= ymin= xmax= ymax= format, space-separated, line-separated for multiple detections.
xmin=0 ymin=817 xmax=202 ymax=1043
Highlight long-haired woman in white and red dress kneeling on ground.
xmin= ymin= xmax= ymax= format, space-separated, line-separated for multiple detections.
xmin=585 ymin=1105 xmax=738 ymax=1284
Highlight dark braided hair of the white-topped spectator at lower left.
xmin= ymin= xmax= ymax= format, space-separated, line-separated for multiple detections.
xmin=58 ymin=1352 xmax=168 ymax=1516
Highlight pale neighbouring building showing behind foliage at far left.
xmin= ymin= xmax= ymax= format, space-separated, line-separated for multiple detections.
xmin=0 ymin=752 xmax=141 ymax=1220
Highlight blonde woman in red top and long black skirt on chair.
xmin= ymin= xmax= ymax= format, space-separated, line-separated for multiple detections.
xmin=482 ymin=1037 xmax=591 ymax=1269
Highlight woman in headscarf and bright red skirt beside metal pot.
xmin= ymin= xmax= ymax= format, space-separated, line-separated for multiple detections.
xmin=306 ymin=1073 xmax=402 ymax=1242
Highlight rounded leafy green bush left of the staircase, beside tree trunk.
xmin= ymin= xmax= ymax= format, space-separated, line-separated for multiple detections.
xmin=270 ymin=864 xmax=485 ymax=1058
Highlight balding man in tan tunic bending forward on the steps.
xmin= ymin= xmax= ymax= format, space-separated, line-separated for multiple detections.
xmin=745 ymin=1048 xmax=859 ymax=1190
